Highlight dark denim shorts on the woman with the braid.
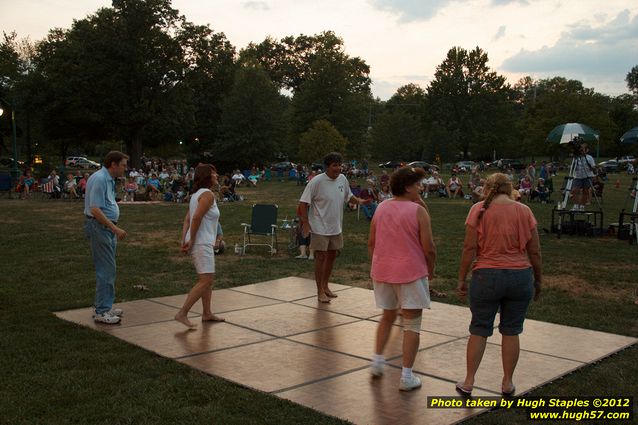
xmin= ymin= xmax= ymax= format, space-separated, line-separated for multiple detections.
xmin=469 ymin=267 xmax=534 ymax=337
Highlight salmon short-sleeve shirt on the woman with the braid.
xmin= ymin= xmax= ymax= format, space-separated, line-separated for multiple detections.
xmin=465 ymin=201 xmax=537 ymax=270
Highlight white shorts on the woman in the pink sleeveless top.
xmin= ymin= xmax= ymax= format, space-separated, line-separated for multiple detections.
xmin=372 ymin=277 xmax=430 ymax=310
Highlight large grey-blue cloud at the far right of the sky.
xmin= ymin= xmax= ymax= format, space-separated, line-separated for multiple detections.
xmin=500 ymin=10 xmax=638 ymax=81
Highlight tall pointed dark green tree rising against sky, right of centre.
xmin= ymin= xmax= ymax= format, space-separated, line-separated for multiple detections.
xmin=426 ymin=47 xmax=513 ymax=158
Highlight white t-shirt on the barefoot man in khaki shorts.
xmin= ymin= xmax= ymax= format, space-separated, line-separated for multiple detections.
xmin=300 ymin=173 xmax=352 ymax=236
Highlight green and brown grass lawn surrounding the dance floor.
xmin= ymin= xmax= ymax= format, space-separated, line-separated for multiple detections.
xmin=0 ymin=169 xmax=638 ymax=424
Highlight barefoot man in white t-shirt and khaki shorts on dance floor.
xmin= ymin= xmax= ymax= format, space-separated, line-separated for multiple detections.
xmin=299 ymin=152 xmax=369 ymax=303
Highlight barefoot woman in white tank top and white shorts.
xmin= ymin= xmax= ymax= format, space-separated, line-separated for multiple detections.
xmin=175 ymin=164 xmax=224 ymax=328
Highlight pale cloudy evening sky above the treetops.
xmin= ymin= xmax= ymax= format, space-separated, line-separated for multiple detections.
xmin=0 ymin=0 xmax=638 ymax=100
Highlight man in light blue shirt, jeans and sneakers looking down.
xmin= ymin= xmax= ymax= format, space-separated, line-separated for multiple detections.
xmin=84 ymin=151 xmax=128 ymax=325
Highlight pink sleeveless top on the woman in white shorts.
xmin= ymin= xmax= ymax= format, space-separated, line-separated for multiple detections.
xmin=370 ymin=200 xmax=428 ymax=283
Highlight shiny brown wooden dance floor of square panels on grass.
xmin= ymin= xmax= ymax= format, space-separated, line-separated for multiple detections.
xmin=56 ymin=277 xmax=638 ymax=424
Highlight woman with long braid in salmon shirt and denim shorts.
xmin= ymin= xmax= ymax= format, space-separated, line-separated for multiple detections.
xmin=456 ymin=173 xmax=542 ymax=396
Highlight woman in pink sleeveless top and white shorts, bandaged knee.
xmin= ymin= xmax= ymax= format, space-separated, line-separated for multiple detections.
xmin=368 ymin=167 xmax=436 ymax=391
